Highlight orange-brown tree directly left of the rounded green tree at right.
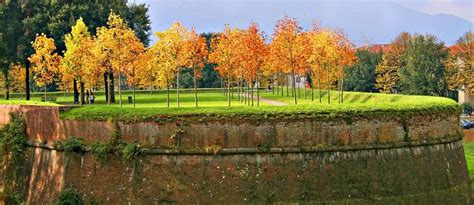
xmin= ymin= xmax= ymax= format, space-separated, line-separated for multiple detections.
xmin=375 ymin=32 xmax=412 ymax=93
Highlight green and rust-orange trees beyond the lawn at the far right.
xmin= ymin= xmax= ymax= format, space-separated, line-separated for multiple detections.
xmin=345 ymin=32 xmax=474 ymax=96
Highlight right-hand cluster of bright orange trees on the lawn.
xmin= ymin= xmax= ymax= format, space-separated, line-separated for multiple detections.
xmin=209 ymin=17 xmax=355 ymax=105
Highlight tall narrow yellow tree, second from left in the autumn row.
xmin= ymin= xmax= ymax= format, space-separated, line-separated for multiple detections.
xmin=61 ymin=18 xmax=93 ymax=105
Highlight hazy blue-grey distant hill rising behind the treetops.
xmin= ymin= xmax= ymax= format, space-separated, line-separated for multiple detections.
xmin=142 ymin=0 xmax=474 ymax=46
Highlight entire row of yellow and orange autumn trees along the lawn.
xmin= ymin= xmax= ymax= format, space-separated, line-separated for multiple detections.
xmin=20 ymin=13 xmax=355 ymax=107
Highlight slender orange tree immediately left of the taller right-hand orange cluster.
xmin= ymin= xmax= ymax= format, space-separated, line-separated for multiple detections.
xmin=183 ymin=29 xmax=208 ymax=107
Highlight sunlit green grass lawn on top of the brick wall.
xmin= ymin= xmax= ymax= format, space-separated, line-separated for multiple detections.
xmin=0 ymin=89 xmax=459 ymax=120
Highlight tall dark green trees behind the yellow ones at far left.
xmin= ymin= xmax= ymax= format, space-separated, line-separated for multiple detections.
xmin=0 ymin=0 xmax=150 ymax=99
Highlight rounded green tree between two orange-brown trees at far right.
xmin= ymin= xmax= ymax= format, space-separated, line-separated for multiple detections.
xmin=399 ymin=35 xmax=448 ymax=96
